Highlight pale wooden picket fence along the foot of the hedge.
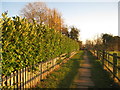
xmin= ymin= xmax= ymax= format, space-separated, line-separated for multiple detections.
xmin=2 ymin=52 xmax=76 ymax=89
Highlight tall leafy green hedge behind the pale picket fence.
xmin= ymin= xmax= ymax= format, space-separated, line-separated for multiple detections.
xmin=2 ymin=14 xmax=79 ymax=75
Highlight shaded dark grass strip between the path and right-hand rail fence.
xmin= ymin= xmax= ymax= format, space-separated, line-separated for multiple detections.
xmin=88 ymin=52 xmax=118 ymax=88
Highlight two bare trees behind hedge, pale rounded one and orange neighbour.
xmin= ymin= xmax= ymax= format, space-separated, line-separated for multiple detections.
xmin=21 ymin=2 xmax=63 ymax=31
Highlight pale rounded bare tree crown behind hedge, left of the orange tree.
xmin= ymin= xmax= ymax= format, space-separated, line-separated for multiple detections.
xmin=21 ymin=2 xmax=48 ymax=23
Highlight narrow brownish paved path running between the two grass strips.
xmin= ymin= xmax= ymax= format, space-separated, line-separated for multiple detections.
xmin=73 ymin=52 xmax=94 ymax=88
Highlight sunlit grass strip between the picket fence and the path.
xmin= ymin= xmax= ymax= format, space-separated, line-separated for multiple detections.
xmin=36 ymin=51 xmax=83 ymax=88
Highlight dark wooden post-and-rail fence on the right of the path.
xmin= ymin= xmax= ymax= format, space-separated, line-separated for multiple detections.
xmin=91 ymin=50 xmax=120 ymax=84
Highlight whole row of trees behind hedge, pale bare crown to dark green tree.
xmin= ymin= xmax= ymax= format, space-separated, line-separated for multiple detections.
xmin=20 ymin=2 xmax=79 ymax=41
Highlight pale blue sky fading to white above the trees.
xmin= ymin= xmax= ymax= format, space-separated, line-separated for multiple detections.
xmin=0 ymin=0 xmax=118 ymax=42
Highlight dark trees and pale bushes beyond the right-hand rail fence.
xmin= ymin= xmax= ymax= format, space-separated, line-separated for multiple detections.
xmin=86 ymin=34 xmax=120 ymax=51
